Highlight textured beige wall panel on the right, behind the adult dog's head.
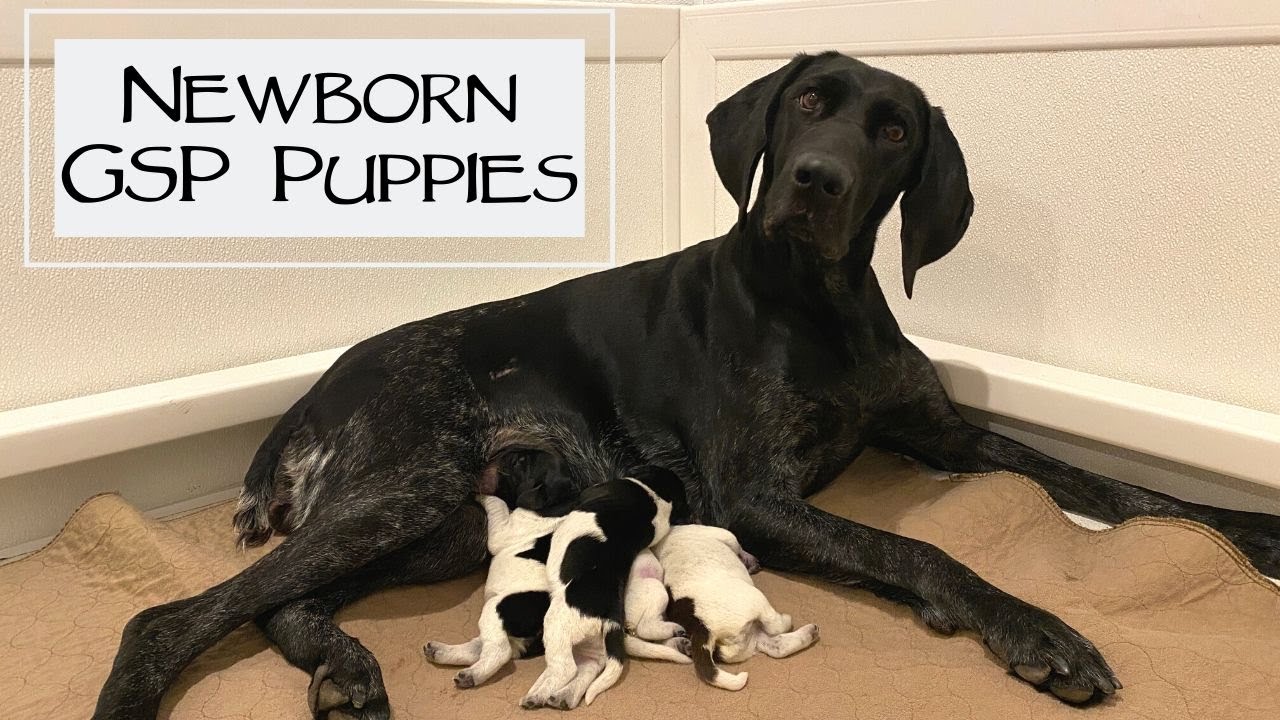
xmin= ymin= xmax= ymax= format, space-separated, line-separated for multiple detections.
xmin=716 ymin=46 xmax=1280 ymax=413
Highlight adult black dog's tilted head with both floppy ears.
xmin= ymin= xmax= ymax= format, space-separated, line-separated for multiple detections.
xmin=707 ymin=53 xmax=973 ymax=297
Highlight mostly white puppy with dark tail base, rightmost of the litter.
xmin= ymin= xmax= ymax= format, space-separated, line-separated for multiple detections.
xmin=654 ymin=525 xmax=818 ymax=691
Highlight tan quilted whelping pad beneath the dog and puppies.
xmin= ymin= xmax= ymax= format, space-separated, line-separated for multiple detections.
xmin=0 ymin=454 xmax=1280 ymax=720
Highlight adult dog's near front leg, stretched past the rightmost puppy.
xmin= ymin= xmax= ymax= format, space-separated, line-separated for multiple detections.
xmin=730 ymin=493 xmax=1120 ymax=703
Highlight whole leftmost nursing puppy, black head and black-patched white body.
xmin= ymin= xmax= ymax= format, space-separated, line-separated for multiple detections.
xmin=422 ymin=451 xmax=572 ymax=688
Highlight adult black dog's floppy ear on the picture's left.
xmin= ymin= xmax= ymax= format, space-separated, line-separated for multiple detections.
xmin=707 ymin=55 xmax=814 ymax=219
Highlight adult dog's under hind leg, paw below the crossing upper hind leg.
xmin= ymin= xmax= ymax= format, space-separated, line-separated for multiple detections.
xmin=267 ymin=502 xmax=486 ymax=719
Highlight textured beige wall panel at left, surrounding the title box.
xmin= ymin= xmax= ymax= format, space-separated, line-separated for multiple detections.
xmin=0 ymin=63 xmax=663 ymax=410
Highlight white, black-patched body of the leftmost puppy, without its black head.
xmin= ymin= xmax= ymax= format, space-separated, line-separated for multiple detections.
xmin=422 ymin=495 xmax=564 ymax=688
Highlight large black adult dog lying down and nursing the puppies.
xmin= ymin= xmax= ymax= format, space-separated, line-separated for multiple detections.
xmin=95 ymin=54 xmax=1280 ymax=720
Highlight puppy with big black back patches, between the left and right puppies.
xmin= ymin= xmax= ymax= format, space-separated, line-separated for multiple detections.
xmin=521 ymin=466 xmax=687 ymax=710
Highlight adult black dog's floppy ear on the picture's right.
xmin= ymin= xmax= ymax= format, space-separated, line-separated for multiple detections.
xmin=900 ymin=108 xmax=973 ymax=297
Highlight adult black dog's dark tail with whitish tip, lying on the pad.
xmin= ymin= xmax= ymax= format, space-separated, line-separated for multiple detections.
xmin=232 ymin=393 xmax=310 ymax=547
